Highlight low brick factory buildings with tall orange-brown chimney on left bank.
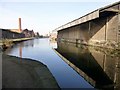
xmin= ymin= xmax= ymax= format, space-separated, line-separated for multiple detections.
xmin=0 ymin=18 xmax=35 ymax=39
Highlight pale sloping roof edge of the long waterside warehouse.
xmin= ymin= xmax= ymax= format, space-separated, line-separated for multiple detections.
xmin=53 ymin=1 xmax=120 ymax=31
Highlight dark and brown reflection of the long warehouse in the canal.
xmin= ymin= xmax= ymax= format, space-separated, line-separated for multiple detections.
xmin=57 ymin=42 xmax=120 ymax=89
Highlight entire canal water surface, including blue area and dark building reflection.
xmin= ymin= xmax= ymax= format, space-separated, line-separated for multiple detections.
xmin=5 ymin=38 xmax=120 ymax=89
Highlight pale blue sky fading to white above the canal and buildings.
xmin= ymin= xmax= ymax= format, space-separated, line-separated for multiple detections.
xmin=0 ymin=0 xmax=119 ymax=35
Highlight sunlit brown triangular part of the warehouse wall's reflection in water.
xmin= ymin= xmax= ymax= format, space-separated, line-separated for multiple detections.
xmin=89 ymin=49 xmax=120 ymax=88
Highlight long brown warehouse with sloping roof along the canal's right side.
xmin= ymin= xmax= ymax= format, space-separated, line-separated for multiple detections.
xmin=54 ymin=2 xmax=120 ymax=49
